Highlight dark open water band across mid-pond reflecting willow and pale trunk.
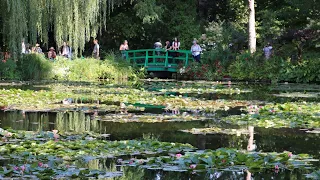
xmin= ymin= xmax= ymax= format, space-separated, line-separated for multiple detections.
xmin=0 ymin=111 xmax=320 ymax=157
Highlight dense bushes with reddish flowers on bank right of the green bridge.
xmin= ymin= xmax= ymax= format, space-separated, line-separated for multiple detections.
xmin=184 ymin=51 xmax=320 ymax=82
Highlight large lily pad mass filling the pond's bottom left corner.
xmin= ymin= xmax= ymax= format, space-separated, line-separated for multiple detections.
xmin=0 ymin=128 xmax=195 ymax=179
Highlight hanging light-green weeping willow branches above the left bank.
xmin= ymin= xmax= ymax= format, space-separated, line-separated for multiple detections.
xmin=0 ymin=0 xmax=133 ymax=57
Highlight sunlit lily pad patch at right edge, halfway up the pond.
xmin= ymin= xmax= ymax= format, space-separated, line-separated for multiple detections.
xmin=222 ymin=102 xmax=320 ymax=128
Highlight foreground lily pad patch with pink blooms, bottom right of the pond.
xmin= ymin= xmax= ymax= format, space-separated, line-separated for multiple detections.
xmin=125 ymin=148 xmax=313 ymax=172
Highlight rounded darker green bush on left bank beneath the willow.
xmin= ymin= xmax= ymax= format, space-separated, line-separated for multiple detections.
xmin=17 ymin=54 xmax=52 ymax=80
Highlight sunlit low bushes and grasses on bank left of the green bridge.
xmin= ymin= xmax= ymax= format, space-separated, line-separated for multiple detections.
xmin=0 ymin=54 xmax=145 ymax=81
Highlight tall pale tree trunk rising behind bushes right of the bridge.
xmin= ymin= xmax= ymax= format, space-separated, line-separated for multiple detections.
xmin=248 ymin=0 xmax=257 ymax=54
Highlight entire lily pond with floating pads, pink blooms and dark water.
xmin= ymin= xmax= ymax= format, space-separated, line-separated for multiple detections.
xmin=0 ymin=80 xmax=320 ymax=179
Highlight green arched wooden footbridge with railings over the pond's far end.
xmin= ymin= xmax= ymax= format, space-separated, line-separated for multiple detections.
xmin=125 ymin=49 xmax=193 ymax=73
